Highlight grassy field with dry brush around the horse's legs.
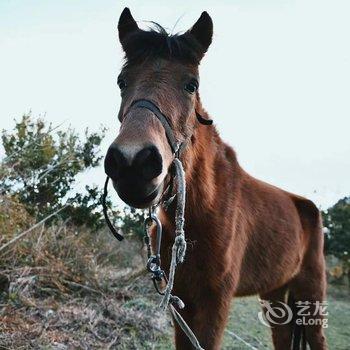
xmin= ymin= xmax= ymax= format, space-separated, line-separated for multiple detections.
xmin=0 ymin=227 xmax=350 ymax=350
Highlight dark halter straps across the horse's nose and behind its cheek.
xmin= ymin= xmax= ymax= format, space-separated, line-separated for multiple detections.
xmin=130 ymin=99 xmax=213 ymax=155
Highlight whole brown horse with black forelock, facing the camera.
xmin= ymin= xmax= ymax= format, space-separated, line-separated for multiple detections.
xmin=105 ymin=8 xmax=326 ymax=350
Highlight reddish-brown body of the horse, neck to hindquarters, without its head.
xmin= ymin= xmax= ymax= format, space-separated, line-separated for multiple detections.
xmin=157 ymin=119 xmax=325 ymax=349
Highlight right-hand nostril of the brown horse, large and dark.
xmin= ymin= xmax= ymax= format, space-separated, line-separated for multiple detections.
xmin=132 ymin=146 xmax=163 ymax=180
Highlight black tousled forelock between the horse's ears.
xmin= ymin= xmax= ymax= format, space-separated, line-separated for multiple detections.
xmin=123 ymin=22 xmax=204 ymax=66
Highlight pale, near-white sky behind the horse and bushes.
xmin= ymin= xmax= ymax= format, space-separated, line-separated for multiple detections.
xmin=0 ymin=0 xmax=350 ymax=209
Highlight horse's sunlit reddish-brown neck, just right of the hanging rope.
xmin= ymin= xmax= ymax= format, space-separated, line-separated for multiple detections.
xmin=164 ymin=119 xmax=240 ymax=223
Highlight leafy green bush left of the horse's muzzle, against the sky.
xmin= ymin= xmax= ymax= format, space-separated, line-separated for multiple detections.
xmin=0 ymin=114 xmax=105 ymax=228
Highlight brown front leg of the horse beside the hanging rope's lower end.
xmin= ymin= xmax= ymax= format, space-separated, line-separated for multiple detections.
xmin=174 ymin=292 xmax=231 ymax=350
